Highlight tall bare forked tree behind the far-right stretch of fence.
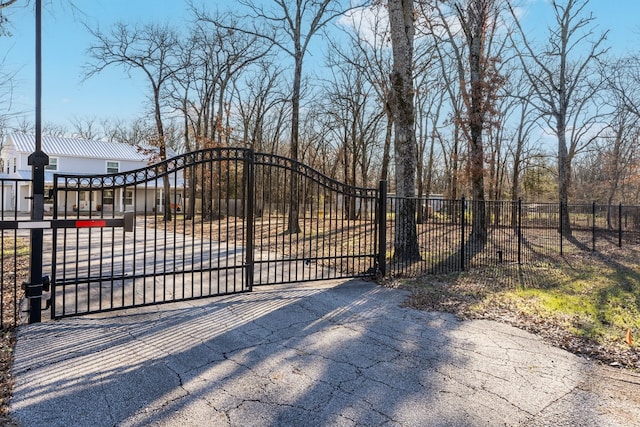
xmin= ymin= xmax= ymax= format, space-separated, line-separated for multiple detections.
xmin=509 ymin=0 xmax=606 ymax=235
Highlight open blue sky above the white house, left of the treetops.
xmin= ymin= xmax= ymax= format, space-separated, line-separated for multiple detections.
xmin=0 ymin=0 xmax=188 ymax=126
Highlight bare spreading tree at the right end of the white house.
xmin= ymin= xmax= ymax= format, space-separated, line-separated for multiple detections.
xmin=85 ymin=23 xmax=184 ymax=221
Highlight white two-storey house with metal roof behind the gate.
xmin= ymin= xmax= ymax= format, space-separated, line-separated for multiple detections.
xmin=0 ymin=134 xmax=184 ymax=212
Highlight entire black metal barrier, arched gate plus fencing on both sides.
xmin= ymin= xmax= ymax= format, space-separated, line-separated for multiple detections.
xmin=6 ymin=155 xmax=640 ymax=327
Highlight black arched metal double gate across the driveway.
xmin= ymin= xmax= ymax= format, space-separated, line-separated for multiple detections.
xmin=50 ymin=148 xmax=378 ymax=318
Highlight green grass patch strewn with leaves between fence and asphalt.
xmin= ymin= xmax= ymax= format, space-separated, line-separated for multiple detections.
xmin=405 ymin=250 xmax=640 ymax=351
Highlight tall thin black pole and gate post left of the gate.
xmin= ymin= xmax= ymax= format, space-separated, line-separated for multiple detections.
xmin=26 ymin=0 xmax=49 ymax=323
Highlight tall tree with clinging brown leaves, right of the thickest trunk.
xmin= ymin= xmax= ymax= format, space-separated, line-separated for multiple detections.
xmin=421 ymin=0 xmax=504 ymax=244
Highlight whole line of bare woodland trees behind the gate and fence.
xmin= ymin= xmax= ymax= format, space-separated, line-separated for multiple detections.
xmin=0 ymin=0 xmax=640 ymax=247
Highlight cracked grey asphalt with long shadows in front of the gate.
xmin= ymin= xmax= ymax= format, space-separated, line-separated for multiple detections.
xmin=10 ymin=280 xmax=640 ymax=427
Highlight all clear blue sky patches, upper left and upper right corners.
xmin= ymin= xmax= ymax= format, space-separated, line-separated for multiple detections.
xmin=0 ymin=0 xmax=640 ymax=130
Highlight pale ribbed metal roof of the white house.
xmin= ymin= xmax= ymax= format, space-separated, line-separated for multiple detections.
xmin=9 ymin=133 xmax=172 ymax=161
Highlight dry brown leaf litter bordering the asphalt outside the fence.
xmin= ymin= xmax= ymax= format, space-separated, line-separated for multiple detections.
xmin=400 ymin=251 xmax=640 ymax=370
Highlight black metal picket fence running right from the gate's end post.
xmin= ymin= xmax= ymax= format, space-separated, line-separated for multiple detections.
xmin=385 ymin=196 xmax=640 ymax=276
